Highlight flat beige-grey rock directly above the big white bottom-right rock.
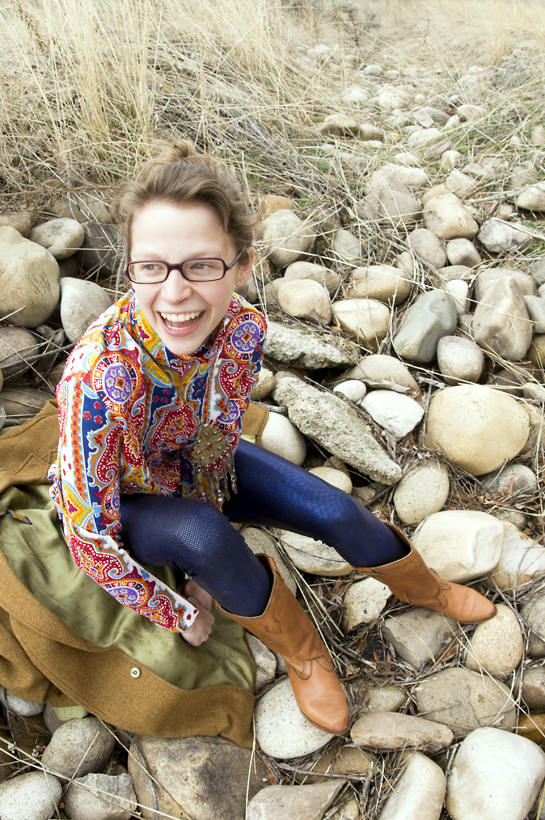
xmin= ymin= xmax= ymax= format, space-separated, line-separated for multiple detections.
xmin=414 ymin=667 xmax=517 ymax=738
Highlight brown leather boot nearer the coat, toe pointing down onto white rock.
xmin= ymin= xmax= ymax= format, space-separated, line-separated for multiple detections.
xmin=216 ymin=555 xmax=350 ymax=735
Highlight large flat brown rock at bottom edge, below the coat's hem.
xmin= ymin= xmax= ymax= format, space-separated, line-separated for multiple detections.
xmin=128 ymin=730 xmax=270 ymax=820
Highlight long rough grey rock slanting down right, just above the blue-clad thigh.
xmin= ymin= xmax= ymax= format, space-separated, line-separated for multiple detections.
xmin=273 ymin=378 xmax=401 ymax=485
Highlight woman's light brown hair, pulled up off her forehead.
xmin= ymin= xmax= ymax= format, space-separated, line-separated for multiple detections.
xmin=112 ymin=140 xmax=256 ymax=265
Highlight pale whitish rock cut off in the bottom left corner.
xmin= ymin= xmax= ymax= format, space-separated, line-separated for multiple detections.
xmin=0 ymin=772 xmax=62 ymax=820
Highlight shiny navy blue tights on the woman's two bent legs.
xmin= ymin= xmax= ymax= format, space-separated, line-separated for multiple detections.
xmin=121 ymin=439 xmax=407 ymax=617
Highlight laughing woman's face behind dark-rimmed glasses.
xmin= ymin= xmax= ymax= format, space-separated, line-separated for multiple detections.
xmin=129 ymin=201 xmax=253 ymax=356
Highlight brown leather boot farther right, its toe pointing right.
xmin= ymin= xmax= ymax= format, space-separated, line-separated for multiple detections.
xmin=358 ymin=521 xmax=496 ymax=624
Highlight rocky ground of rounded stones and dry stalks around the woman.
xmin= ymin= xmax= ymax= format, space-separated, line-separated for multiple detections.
xmin=0 ymin=4 xmax=545 ymax=820
